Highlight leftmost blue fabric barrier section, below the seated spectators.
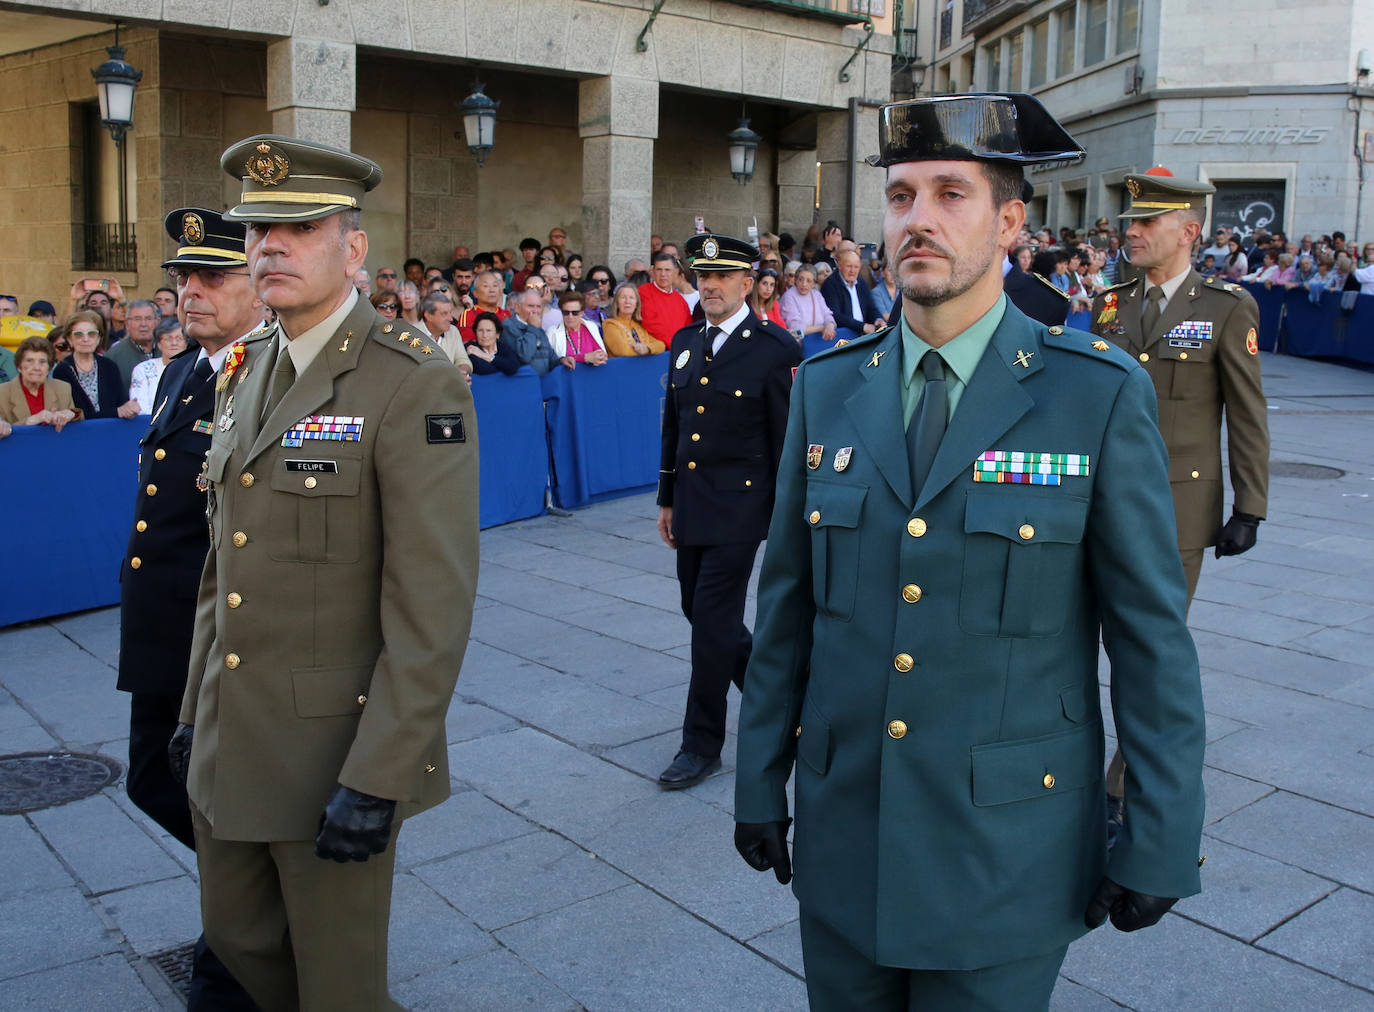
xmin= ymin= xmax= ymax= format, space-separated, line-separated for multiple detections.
xmin=0 ymin=417 xmax=148 ymax=626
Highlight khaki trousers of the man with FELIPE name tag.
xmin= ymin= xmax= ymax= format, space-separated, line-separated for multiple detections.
xmin=191 ymin=805 xmax=400 ymax=1012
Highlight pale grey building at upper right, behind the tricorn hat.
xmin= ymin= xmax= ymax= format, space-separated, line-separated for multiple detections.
xmin=914 ymin=0 xmax=1374 ymax=238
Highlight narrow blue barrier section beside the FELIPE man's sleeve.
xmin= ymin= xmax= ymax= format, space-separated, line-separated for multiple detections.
xmin=473 ymin=365 xmax=548 ymax=527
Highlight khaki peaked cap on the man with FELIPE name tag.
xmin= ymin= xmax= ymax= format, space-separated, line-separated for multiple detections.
xmin=220 ymin=133 xmax=382 ymax=224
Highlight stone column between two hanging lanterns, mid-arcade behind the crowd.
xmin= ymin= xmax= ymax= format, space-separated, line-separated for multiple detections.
xmin=577 ymin=76 xmax=658 ymax=276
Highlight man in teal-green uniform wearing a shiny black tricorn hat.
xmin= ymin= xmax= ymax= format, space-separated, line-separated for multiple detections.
xmin=735 ymin=95 xmax=1204 ymax=1012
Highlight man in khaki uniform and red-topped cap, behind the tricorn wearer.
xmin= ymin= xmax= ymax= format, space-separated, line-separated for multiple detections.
xmin=1092 ymin=168 xmax=1270 ymax=836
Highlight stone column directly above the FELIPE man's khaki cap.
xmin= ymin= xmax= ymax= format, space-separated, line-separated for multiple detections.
xmin=267 ymin=37 xmax=357 ymax=150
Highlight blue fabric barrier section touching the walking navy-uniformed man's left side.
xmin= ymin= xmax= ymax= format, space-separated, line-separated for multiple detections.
xmin=541 ymin=352 xmax=672 ymax=509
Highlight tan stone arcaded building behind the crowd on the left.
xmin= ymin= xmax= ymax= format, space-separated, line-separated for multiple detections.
xmin=0 ymin=0 xmax=901 ymax=310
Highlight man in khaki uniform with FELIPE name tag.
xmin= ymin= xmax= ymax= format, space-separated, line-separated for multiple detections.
xmin=172 ymin=136 xmax=478 ymax=1012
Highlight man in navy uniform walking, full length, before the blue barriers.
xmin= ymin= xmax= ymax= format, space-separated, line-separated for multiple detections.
xmin=658 ymin=233 xmax=801 ymax=790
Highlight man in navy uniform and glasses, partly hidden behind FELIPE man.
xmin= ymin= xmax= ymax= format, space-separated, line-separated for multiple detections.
xmin=117 ymin=207 xmax=262 ymax=1012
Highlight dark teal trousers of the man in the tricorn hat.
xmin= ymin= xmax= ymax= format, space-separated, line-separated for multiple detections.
xmin=801 ymin=910 xmax=1069 ymax=1012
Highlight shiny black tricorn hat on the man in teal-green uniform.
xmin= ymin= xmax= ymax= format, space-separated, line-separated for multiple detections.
xmin=868 ymin=93 xmax=1083 ymax=166
